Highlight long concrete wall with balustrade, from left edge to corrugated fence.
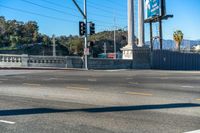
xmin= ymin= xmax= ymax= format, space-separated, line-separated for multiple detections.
xmin=0 ymin=49 xmax=150 ymax=69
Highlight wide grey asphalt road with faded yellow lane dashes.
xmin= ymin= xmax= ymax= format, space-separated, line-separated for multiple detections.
xmin=0 ymin=70 xmax=200 ymax=133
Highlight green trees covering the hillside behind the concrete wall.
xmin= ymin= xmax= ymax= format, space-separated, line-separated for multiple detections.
xmin=0 ymin=16 xmax=127 ymax=56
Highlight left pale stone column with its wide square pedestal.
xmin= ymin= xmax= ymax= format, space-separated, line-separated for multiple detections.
xmin=122 ymin=0 xmax=136 ymax=59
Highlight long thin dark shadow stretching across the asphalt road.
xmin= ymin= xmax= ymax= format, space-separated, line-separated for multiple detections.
xmin=0 ymin=103 xmax=200 ymax=116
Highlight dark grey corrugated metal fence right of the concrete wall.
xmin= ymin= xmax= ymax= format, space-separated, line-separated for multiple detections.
xmin=151 ymin=50 xmax=200 ymax=70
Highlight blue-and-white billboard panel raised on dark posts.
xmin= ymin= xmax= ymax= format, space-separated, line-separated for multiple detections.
xmin=145 ymin=0 xmax=165 ymax=19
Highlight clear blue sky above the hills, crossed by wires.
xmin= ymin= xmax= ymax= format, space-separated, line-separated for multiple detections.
xmin=0 ymin=0 xmax=200 ymax=40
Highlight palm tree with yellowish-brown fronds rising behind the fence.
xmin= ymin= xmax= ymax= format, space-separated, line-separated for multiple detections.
xmin=173 ymin=30 xmax=183 ymax=51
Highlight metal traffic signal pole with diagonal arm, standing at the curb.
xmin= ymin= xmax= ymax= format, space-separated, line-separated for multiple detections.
xmin=72 ymin=0 xmax=88 ymax=70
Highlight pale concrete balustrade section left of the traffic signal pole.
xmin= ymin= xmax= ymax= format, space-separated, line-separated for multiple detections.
xmin=0 ymin=54 xmax=83 ymax=68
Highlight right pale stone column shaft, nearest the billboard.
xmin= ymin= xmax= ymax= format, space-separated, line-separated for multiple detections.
xmin=138 ymin=0 xmax=145 ymax=47
